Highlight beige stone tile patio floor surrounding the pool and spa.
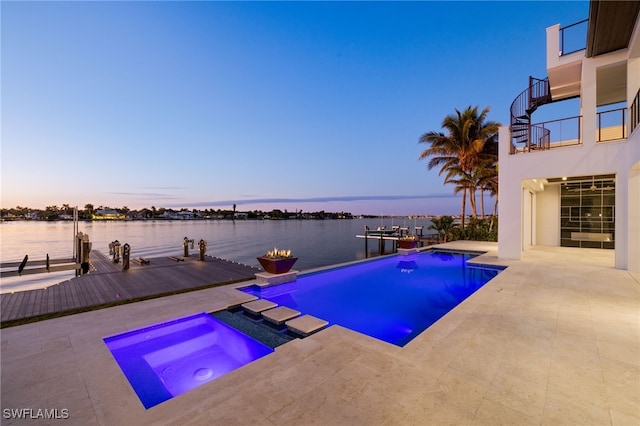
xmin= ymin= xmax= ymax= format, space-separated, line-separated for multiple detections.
xmin=0 ymin=242 xmax=640 ymax=425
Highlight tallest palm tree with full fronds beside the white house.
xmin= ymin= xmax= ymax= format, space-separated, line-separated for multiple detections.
xmin=418 ymin=106 xmax=500 ymax=230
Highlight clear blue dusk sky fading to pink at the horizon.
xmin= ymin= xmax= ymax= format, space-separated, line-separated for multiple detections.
xmin=0 ymin=1 xmax=588 ymax=215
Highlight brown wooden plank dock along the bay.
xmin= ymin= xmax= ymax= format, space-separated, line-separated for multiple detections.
xmin=0 ymin=252 xmax=262 ymax=327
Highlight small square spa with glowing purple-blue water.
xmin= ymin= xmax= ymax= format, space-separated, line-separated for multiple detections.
xmin=104 ymin=313 xmax=273 ymax=408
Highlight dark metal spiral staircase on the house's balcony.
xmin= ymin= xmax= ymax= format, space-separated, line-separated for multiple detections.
xmin=509 ymin=77 xmax=552 ymax=154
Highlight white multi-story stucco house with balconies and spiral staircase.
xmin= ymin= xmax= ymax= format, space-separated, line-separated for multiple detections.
xmin=498 ymin=0 xmax=640 ymax=272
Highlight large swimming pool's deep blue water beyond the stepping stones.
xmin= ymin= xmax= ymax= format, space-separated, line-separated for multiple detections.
xmin=242 ymin=251 xmax=504 ymax=346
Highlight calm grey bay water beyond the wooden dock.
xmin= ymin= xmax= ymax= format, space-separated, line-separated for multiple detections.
xmin=0 ymin=217 xmax=433 ymax=293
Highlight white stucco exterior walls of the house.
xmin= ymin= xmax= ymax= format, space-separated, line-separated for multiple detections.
xmin=498 ymin=15 xmax=640 ymax=271
